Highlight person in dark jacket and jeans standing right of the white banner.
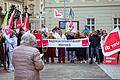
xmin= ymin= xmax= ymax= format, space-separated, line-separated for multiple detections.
xmin=89 ymin=31 xmax=100 ymax=64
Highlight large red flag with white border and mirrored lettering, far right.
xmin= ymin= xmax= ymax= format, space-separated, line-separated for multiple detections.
xmin=101 ymin=27 xmax=120 ymax=56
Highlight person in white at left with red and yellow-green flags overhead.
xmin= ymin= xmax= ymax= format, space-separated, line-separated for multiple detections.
xmin=2 ymin=6 xmax=17 ymax=72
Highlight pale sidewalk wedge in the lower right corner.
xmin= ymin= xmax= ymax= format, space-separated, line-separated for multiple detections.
xmin=98 ymin=64 xmax=120 ymax=79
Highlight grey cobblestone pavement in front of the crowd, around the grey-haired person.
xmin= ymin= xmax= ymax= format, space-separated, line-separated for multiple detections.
xmin=0 ymin=61 xmax=111 ymax=80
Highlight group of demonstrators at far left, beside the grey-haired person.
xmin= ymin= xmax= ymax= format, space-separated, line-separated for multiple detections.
xmin=0 ymin=28 xmax=44 ymax=72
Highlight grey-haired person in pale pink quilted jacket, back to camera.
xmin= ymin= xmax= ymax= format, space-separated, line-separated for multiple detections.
xmin=12 ymin=33 xmax=44 ymax=80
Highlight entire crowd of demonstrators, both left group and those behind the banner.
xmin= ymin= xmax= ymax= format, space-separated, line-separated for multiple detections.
xmin=0 ymin=26 xmax=107 ymax=74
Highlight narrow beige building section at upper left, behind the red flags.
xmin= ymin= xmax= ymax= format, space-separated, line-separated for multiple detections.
xmin=24 ymin=0 xmax=44 ymax=30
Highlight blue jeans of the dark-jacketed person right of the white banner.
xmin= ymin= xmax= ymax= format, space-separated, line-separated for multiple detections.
xmin=90 ymin=47 xmax=100 ymax=63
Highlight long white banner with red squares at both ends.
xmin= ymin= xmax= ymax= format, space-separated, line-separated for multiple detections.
xmin=43 ymin=38 xmax=89 ymax=47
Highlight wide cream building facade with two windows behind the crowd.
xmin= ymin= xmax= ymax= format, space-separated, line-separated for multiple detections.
xmin=44 ymin=0 xmax=120 ymax=32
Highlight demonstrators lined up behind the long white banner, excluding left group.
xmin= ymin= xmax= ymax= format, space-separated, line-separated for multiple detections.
xmin=38 ymin=26 xmax=107 ymax=64
